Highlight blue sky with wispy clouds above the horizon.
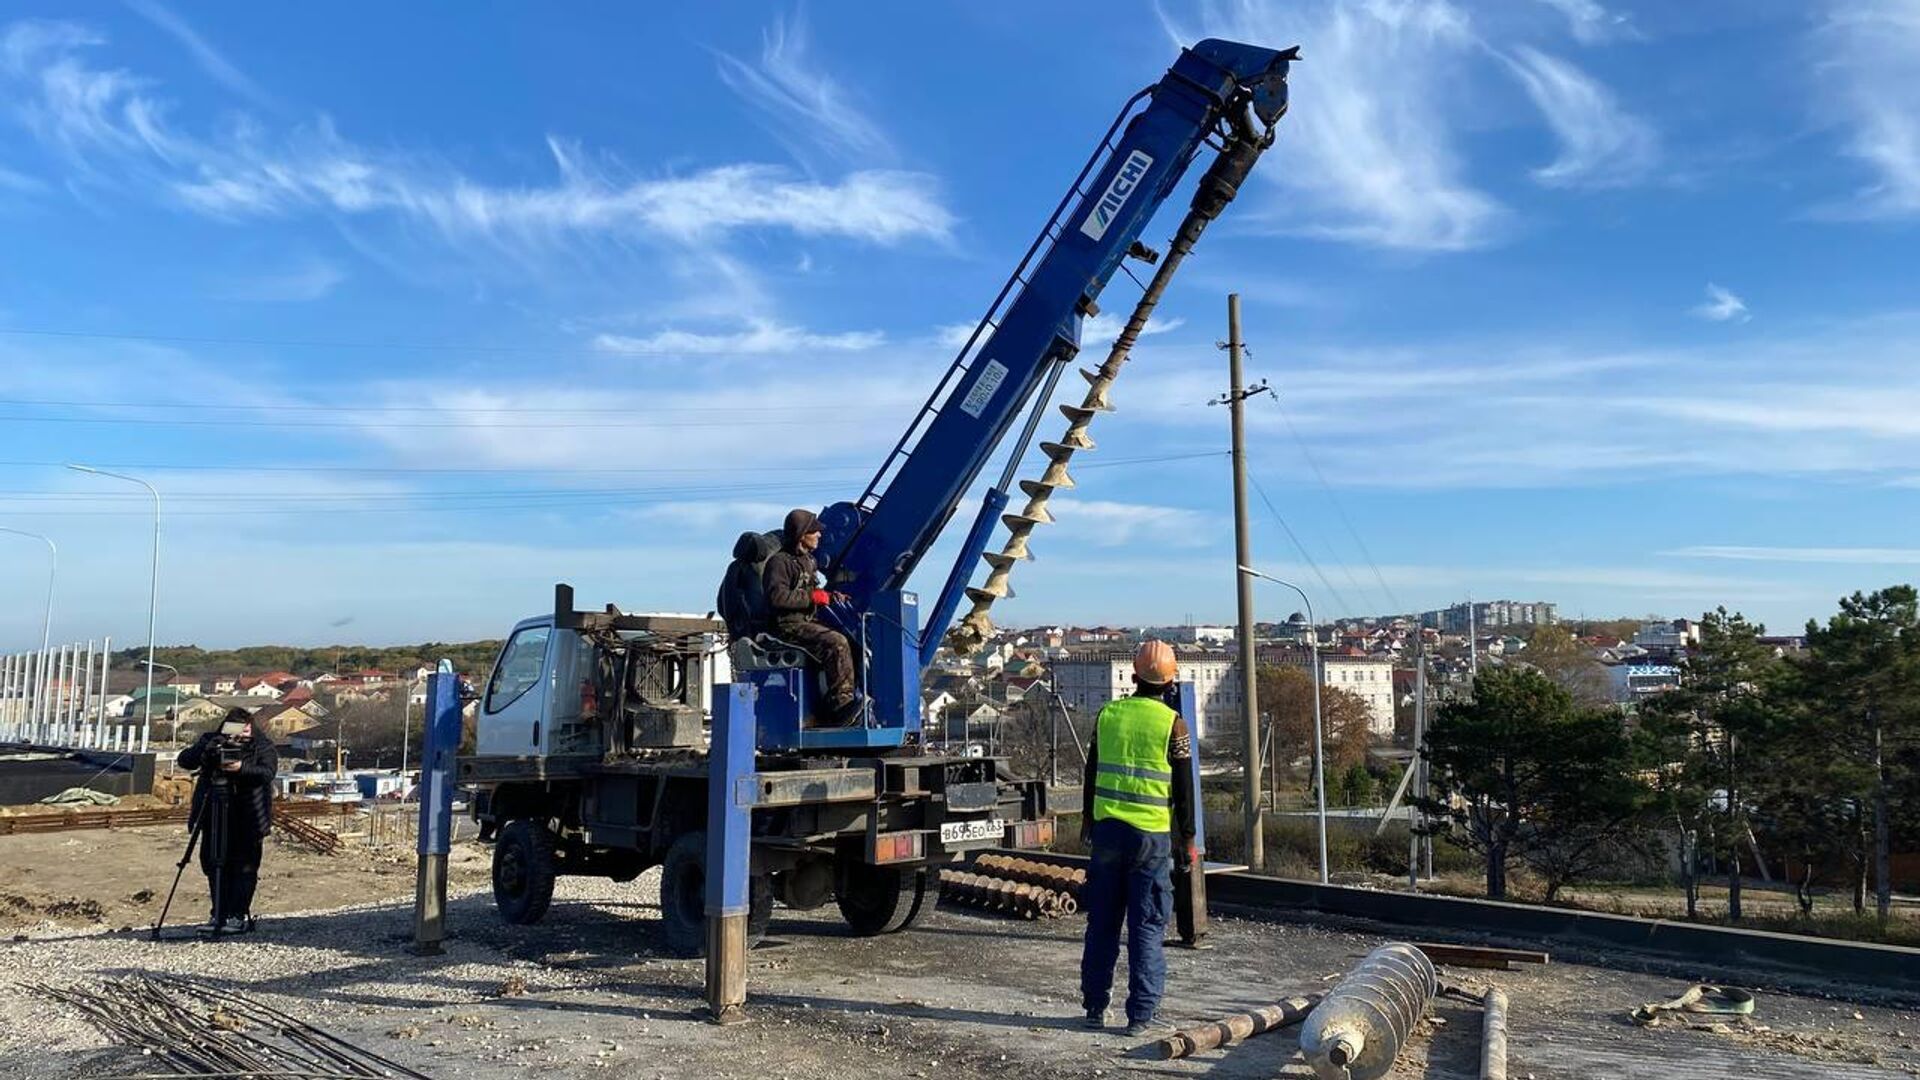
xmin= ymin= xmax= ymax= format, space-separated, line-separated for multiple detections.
xmin=0 ymin=0 xmax=1920 ymax=648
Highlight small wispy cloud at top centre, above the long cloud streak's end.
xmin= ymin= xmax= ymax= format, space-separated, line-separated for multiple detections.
xmin=718 ymin=15 xmax=895 ymax=165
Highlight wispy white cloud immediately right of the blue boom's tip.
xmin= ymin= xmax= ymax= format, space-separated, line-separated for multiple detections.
xmin=1188 ymin=0 xmax=1507 ymax=252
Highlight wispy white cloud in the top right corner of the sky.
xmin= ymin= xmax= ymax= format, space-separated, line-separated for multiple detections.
xmin=1812 ymin=0 xmax=1920 ymax=219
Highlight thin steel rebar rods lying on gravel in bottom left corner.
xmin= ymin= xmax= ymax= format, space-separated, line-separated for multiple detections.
xmin=33 ymin=974 xmax=430 ymax=1080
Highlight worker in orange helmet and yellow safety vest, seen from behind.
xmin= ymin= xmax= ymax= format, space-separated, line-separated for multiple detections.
xmin=1081 ymin=642 xmax=1194 ymax=1036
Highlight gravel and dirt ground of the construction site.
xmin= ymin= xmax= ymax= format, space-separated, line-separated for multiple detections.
xmin=0 ymin=828 xmax=1920 ymax=1080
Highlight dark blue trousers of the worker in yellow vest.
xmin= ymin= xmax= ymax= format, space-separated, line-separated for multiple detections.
xmin=1081 ymin=819 xmax=1173 ymax=1022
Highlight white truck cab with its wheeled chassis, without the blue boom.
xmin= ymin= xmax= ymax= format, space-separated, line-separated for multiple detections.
xmin=459 ymin=586 xmax=1052 ymax=955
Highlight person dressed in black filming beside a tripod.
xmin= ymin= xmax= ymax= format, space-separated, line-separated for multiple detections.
xmin=179 ymin=709 xmax=280 ymax=934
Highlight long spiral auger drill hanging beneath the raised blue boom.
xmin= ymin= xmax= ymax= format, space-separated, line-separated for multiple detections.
xmin=947 ymin=85 xmax=1277 ymax=655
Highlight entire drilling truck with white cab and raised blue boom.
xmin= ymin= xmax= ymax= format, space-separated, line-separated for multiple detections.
xmin=459 ymin=40 xmax=1298 ymax=955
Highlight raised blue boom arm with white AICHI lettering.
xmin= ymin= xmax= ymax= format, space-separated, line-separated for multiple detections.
xmin=820 ymin=40 xmax=1298 ymax=655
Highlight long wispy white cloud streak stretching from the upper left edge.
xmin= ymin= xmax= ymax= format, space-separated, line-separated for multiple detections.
xmin=0 ymin=21 xmax=954 ymax=246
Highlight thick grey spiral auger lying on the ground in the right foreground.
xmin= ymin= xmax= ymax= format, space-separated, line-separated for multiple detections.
xmin=1300 ymin=944 xmax=1440 ymax=1080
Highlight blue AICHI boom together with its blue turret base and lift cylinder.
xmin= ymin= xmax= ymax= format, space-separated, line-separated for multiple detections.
xmin=716 ymin=40 xmax=1296 ymax=751
